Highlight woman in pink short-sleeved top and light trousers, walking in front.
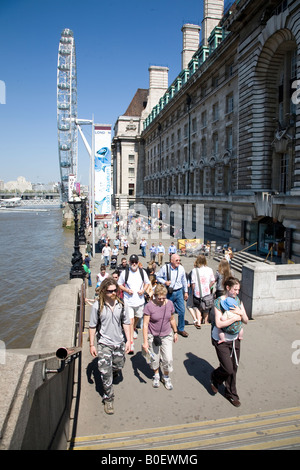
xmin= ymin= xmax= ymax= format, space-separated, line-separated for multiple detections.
xmin=142 ymin=284 xmax=178 ymax=390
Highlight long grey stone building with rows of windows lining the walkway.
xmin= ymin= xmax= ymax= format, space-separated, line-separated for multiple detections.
xmin=112 ymin=0 xmax=300 ymax=262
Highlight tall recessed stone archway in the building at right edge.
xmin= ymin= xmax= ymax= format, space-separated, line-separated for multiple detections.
xmin=252 ymin=28 xmax=297 ymax=190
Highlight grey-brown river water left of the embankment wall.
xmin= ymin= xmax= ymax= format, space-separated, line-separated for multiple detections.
xmin=0 ymin=207 xmax=74 ymax=349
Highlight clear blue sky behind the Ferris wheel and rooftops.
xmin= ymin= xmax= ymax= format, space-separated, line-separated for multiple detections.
xmin=0 ymin=0 xmax=203 ymax=184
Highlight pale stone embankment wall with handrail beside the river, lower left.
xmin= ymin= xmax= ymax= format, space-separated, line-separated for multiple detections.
xmin=0 ymin=279 xmax=82 ymax=450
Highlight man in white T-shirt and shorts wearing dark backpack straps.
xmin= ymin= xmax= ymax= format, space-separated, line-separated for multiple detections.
xmin=118 ymin=255 xmax=150 ymax=354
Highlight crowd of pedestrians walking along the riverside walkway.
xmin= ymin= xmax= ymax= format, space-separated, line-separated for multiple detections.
xmin=85 ymin=237 xmax=247 ymax=414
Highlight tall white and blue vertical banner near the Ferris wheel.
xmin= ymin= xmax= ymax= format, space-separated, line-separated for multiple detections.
xmin=95 ymin=124 xmax=111 ymax=219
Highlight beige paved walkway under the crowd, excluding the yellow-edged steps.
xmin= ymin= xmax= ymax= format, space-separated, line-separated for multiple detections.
xmin=68 ymin=237 xmax=300 ymax=448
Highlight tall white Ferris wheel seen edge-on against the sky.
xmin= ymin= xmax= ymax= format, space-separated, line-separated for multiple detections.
xmin=57 ymin=29 xmax=78 ymax=201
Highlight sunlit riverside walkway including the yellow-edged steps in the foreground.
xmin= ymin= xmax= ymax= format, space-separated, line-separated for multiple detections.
xmin=69 ymin=241 xmax=300 ymax=452
